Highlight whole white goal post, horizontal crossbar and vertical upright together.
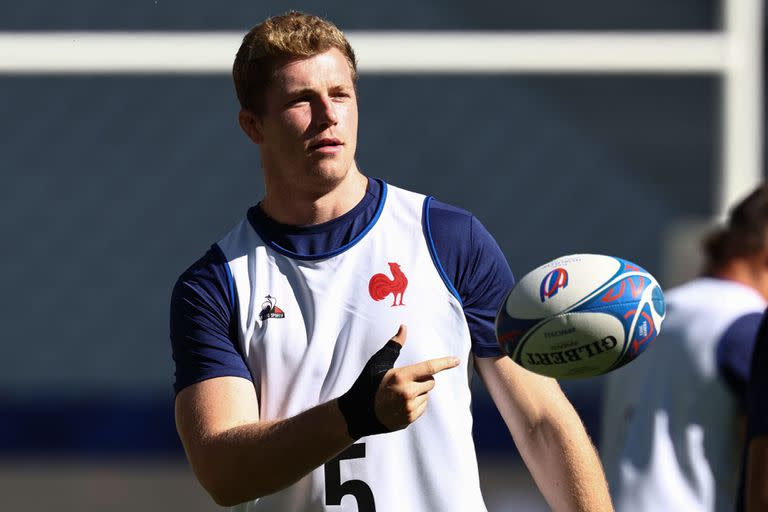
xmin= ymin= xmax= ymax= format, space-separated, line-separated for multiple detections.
xmin=0 ymin=0 xmax=763 ymax=218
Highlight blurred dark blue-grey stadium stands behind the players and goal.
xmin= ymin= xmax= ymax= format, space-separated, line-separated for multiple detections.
xmin=0 ymin=0 xmax=763 ymax=512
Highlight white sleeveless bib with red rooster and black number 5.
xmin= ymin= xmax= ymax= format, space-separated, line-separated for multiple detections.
xmin=219 ymin=186 xmax=486 ymax=512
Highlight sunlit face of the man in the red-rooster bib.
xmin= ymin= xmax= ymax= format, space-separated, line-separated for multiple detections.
xmin=249 ymin=48 xmax=357 ymax=190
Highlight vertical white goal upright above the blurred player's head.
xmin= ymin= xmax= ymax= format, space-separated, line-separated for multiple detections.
xmin=715 ymin=0 xmax=763 ymax=220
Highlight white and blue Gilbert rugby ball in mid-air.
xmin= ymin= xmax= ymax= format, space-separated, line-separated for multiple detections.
xmin=496 ymin=254 xmax=665 ymax=378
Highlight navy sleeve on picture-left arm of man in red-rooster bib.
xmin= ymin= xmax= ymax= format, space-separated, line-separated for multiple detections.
xmin=170 ymin=246 xmax=251 ymax=393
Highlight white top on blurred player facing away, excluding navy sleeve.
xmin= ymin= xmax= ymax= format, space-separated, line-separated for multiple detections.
xmin=600 ymin=278 xmax=766 ymax=512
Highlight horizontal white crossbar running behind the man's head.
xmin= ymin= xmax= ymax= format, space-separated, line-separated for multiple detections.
xmin=0 ymin=31 xmax=728 ymax=74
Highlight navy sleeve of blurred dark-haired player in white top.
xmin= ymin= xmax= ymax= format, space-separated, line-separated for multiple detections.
xmin=716 ymin=313 xmax=763 ymax=405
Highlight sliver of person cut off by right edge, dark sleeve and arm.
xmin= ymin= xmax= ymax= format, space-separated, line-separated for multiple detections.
xmin=736 ymin=311 xmax=768 ymax=512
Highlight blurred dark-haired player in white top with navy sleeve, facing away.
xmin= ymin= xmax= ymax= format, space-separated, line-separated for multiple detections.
xmin=600 ymin=185 xmax=768 ymax=512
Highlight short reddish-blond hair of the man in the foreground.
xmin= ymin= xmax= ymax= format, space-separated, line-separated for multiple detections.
xmin=232 ymin=11 xmax=357 ymax=115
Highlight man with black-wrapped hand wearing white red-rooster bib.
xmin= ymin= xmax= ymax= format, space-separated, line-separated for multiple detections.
xmin=171 ymin=12 xmax=611 ymax=512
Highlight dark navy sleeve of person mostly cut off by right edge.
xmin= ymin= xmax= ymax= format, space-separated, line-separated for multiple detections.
xmin=747 ymin=312 xmax=768 ymax=439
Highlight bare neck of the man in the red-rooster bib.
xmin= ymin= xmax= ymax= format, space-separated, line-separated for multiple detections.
xmin=261 ymin=166 xmax=368 ymax=226
